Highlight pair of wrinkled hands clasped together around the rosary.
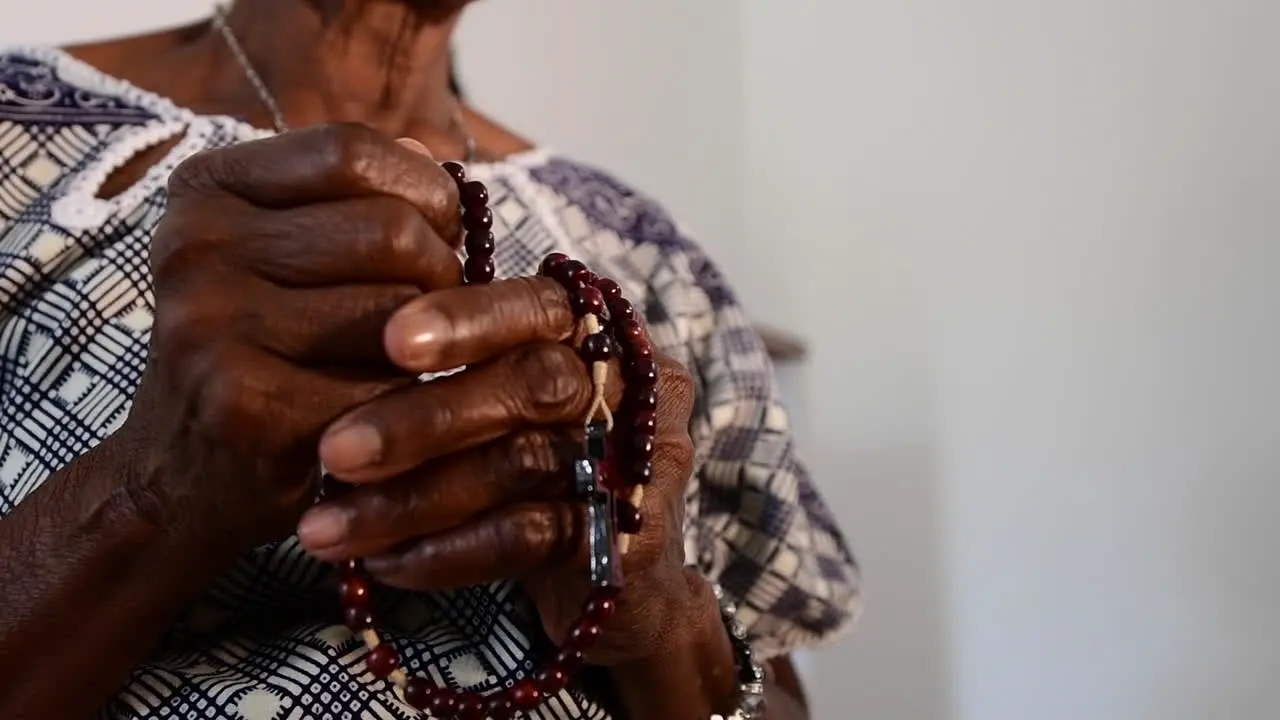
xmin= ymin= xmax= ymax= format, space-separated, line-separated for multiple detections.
xmin=120 ymin=126 xmax=692 ymax=662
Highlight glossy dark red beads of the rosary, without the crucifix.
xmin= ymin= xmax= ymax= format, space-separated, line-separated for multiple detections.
xmin=338 ymin=163 xmax=657 ymax=720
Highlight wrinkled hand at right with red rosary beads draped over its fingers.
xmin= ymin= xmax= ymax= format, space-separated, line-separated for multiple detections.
xmin=298 ymin=278 xmax=694 ymax=664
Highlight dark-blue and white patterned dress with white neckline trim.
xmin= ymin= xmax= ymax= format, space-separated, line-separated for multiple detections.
xmin=0 ymin=46 xmax=858 ymax=720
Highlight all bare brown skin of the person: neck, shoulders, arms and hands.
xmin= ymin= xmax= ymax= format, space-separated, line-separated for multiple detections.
xmin=0 ymin=0 xmax=806 ymax=720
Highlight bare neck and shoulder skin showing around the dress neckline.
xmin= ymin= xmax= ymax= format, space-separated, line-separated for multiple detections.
xmin=68 ymin=0 xmax=532 ymax=166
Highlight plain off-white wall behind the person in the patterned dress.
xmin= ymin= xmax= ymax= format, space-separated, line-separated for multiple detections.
xmin=10 ymin=0 xmax=1280 ymax=720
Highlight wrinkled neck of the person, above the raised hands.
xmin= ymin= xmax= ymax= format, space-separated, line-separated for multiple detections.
xmin=206 ymin=0 xmax=461 ymax=145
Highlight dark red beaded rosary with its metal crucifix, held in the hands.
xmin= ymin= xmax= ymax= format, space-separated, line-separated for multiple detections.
xmin=326 ymin=163 xmax=658 ymax=720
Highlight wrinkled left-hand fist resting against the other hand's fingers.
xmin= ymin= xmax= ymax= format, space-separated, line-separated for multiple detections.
xmin=114 ymin=124 xmax=462 ymax=552
